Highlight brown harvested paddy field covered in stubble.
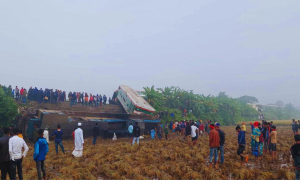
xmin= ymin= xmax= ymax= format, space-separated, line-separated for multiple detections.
xmin=23 ymin=124 xmax=294 ymax=180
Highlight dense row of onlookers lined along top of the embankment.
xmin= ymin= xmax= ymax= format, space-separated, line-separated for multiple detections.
xmin=0 ymin=85 xmax=111 ymax=107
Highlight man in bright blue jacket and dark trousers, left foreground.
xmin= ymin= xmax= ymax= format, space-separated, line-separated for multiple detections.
xmin=33 ymin=129 xmax=49 ymax=180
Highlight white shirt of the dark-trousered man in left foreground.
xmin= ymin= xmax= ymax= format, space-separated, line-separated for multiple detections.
xmin=8 ymin=135 xmax=28 ymax=161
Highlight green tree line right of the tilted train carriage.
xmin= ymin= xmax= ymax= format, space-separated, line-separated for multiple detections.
xmin=144 ymin=86 xmax=300 ymax=125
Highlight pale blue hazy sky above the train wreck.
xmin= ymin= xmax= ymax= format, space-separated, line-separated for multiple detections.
xmin=0 ymin=0 xmax=300 ymax=106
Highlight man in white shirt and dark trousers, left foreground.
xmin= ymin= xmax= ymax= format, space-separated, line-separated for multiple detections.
xmin=9 ymin=128 xmax=28 ymax=180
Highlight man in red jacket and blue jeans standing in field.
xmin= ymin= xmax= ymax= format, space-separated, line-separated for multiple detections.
xmin=209 ymin=124 xmax=220 ymax=168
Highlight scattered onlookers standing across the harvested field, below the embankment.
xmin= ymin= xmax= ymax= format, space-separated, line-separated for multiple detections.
xmin=4 ymin=120 xmax=300 ymax=179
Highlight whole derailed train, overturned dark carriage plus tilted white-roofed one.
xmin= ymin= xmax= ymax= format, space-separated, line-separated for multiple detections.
xmin=21 ymin=85 xmax=159 ymax=139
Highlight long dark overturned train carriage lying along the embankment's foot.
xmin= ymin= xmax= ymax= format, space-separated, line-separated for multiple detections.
xmin=23 ymin=110 xmax=159 ymax=140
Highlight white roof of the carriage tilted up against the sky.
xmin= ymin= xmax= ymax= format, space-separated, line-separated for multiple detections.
xmin=120 ymin=85 xmax=155 ymax=112
